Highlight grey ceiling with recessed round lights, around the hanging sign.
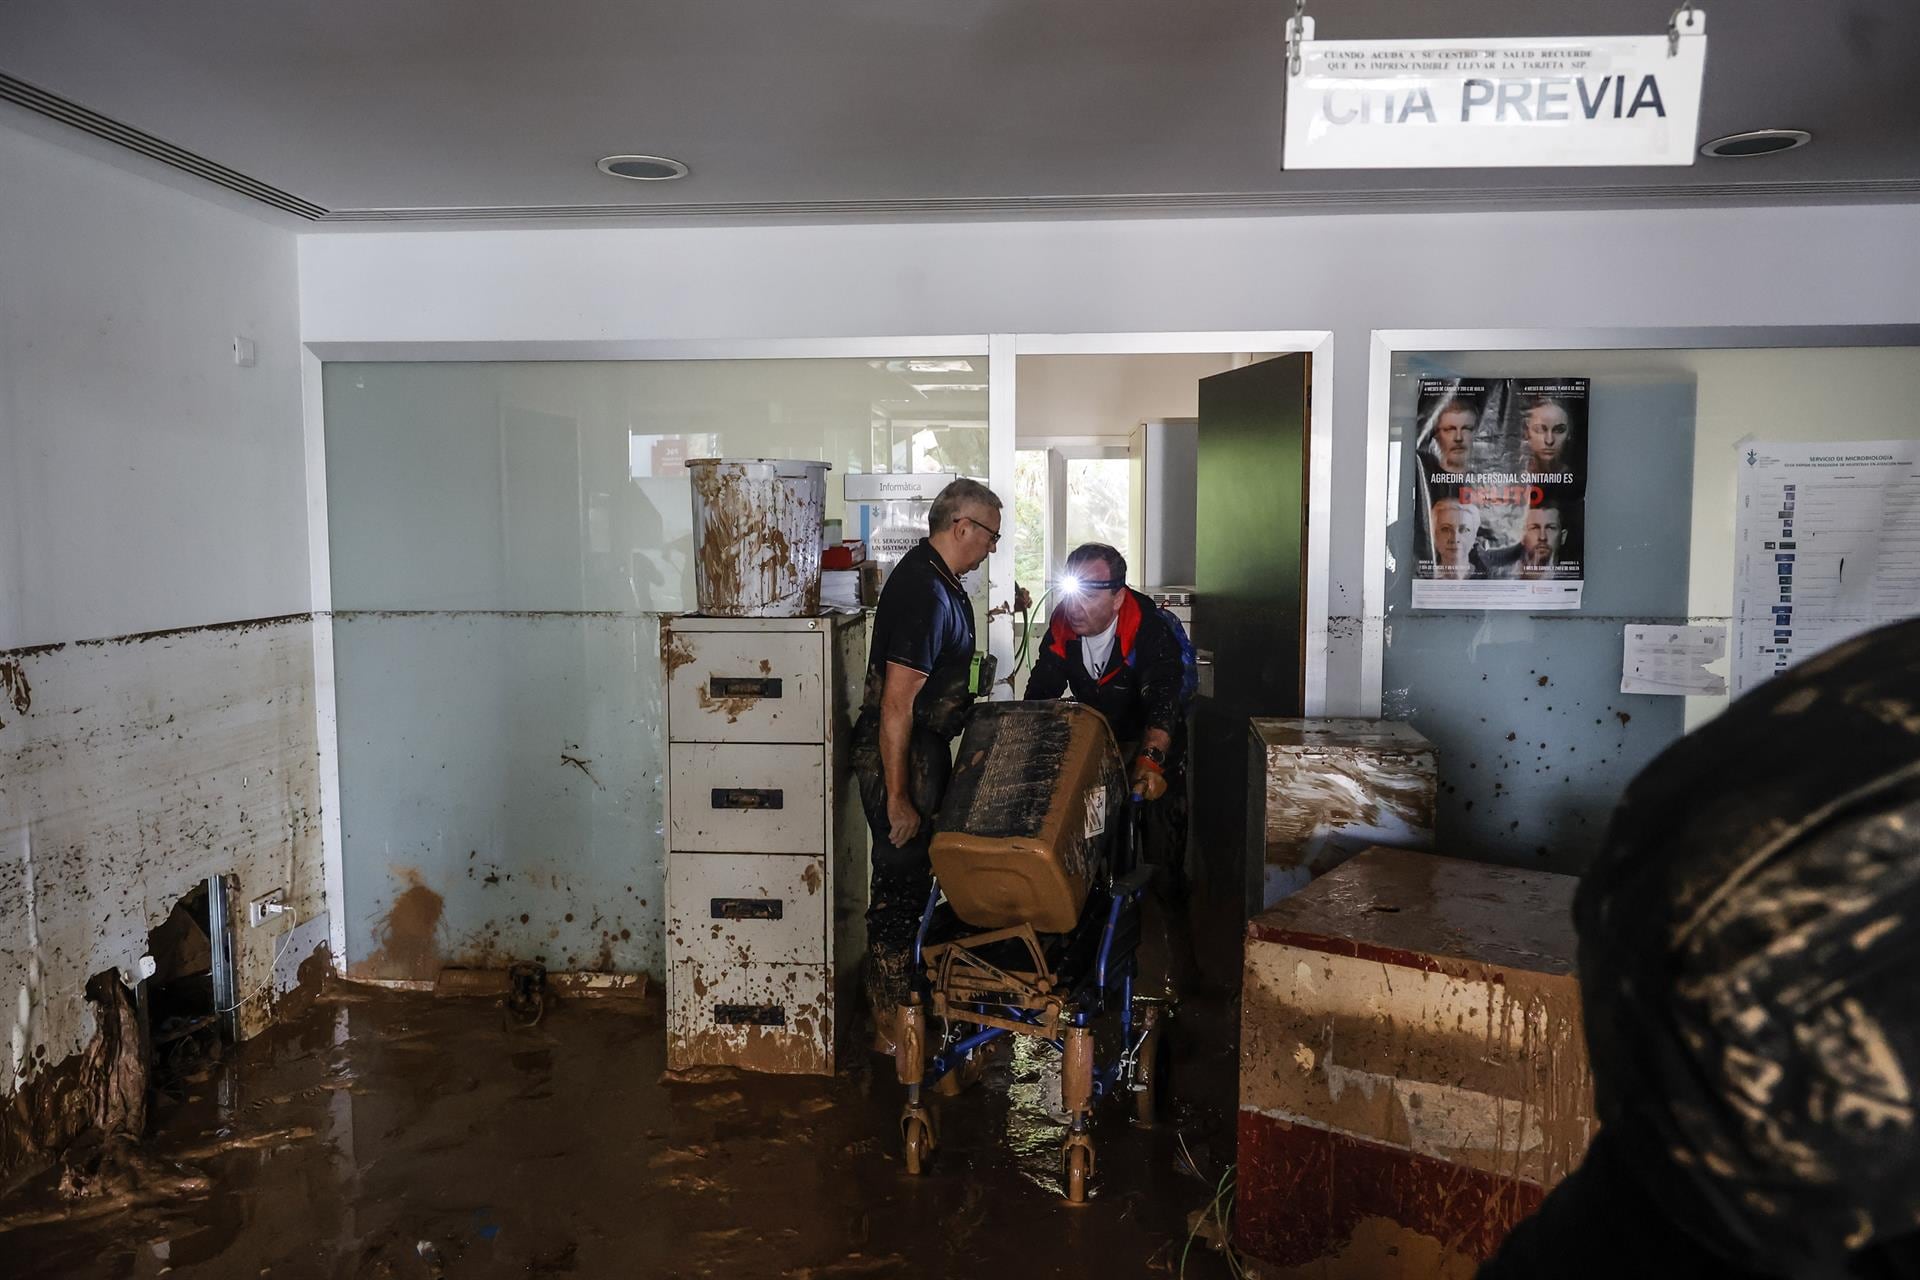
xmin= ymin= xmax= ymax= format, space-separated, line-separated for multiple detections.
xmin=0 ymin=0 xmax=1920 ymax=225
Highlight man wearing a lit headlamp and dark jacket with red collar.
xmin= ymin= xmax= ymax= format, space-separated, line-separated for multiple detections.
xmin=1027 ymin=543 xmax=1192 ymax=896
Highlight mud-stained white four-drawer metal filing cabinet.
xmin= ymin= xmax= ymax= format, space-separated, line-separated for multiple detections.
xmin=660 ymin=614 xmax=868 ymax=1075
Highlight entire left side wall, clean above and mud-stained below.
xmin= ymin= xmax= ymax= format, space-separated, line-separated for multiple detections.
xmin=0 ymin=123 xmax=324 ymax=1143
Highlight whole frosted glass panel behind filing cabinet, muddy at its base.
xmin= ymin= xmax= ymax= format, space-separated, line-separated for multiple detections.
xmin=324 ymin=357 xmax=987 ymax=981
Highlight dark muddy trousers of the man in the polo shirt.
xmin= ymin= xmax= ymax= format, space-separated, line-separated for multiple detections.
xmin=854 ymin=727 xmax=952 ymax=1015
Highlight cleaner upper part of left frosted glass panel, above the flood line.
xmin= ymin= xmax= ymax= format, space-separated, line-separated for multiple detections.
xmin=323 ymin=357 xmax=987 ymax=612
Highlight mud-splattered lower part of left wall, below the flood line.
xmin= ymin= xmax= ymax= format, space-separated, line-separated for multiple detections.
xmin=0 ymin=616 xmax=324 ymax=1178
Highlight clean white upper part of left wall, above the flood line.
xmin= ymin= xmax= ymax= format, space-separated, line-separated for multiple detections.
xmin=0 ymin=125 xmax=307 ymax=649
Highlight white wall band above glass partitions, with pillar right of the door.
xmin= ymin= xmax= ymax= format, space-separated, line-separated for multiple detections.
xmin=300 ymin=205 xmax=1920 ymax=710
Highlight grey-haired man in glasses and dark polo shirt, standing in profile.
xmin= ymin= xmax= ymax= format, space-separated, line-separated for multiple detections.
xmin=852 ymin=480 xmax=1000 ymax=1052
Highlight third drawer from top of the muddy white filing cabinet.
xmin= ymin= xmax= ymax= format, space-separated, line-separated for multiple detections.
xmin=666 ymin=854 xmax=828 ymax=965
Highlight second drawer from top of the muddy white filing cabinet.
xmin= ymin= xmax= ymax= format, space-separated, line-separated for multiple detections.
xmin=666 ymin=743 xmax=826 ymax=854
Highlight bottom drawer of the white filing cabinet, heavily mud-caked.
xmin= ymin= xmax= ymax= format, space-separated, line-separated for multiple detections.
xmin=666 ymin=958 xmax=833 ymax=1075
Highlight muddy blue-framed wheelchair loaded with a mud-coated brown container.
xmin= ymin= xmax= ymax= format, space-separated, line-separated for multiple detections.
xmin=895 ymin=702 xmax=1167 ymax=1201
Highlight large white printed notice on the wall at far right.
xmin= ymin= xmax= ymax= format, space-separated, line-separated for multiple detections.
xmin=1732 ymin=439 xmax=1920 ymax=699
